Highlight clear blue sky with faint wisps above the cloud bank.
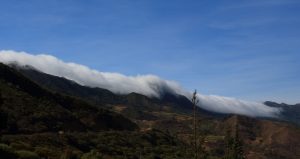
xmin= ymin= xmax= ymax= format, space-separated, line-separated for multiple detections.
xmin=0 ymin=0 xmax=300 ymax=103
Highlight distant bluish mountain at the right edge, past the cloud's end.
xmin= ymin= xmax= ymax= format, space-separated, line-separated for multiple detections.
xmin=264 ymin=101 xmax=300 ymax=125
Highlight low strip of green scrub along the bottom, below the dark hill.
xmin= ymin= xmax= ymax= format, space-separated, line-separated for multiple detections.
xmin=1 ymin=130 xmax=195 ymax=159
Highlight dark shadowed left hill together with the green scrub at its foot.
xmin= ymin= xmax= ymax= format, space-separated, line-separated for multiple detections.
xmin=0 ymin=64 xmax=195 ymax=159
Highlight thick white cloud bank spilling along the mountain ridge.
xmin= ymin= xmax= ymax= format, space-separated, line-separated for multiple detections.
xmin=0 ymin=50 xmax=280 ymax=117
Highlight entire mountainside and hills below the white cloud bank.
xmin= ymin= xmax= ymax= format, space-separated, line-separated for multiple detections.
xmin=0 ymin=64 xmax=300 ymax=159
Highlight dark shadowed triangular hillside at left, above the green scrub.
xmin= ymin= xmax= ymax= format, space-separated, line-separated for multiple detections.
xmin=0 ymin=63 xmax=138 ymax=133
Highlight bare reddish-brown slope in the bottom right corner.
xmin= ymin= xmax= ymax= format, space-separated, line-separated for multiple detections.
xmin=223 ymin=115 xmax=300 ymax=159
